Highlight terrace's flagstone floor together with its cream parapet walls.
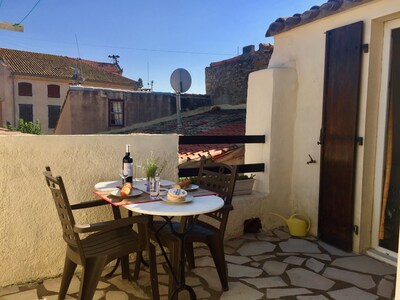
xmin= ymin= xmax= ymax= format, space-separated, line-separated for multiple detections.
xmin=0 ymin=134 xmax=396 ymax=299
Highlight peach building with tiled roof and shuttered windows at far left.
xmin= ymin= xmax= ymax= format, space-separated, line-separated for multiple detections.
xmin=0 ymin=48 xmax=139 ymax=133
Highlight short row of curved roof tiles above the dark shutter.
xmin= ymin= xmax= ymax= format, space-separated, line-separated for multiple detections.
xmin=265 ymin=0 xmax=374 ymax=37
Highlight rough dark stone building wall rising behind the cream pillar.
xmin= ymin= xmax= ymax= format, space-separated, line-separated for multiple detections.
xmin=205 ymin=44 xmax=273 ymax=105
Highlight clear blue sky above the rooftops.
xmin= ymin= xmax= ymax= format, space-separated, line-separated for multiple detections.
xmin=0 ymin=0 xmax=318 ymax=94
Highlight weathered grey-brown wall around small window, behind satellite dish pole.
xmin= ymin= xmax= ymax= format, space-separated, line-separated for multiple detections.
xmin=55 ymin=87 xmax=211 ymax=134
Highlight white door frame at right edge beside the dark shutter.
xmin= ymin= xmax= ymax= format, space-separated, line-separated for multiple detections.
xmin=371 ymin=19 xmax=400 ymax=261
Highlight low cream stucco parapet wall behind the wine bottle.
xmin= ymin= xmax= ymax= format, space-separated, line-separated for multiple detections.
xmin=0 ymin=135 xmax=178 ymax=286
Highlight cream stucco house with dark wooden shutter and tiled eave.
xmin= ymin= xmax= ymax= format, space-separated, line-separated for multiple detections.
xmin=245 ymin=0 xmax=400 ymax=263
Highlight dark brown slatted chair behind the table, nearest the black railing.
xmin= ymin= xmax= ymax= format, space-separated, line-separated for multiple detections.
xmin=150 ymin=159 xmax=237 ymax=293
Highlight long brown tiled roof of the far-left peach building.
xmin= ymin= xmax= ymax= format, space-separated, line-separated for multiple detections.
xmin=0 ymin=48 xmax=137 ymax=87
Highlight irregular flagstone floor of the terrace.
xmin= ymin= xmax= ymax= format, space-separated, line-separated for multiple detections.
xmin=0 ymin=229 xmax=396 ymax=300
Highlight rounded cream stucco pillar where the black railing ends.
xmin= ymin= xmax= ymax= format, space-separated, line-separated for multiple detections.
xmin=245 ymin=68 xmax=297 ymax=228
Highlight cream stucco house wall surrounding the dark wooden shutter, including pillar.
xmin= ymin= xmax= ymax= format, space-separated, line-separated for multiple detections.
xmin=246 ymin=0 xmax=400 ymax=251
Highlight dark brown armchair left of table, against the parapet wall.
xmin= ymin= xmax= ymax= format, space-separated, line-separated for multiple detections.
xmin=43 ymin=167 xmax=159 ymax=300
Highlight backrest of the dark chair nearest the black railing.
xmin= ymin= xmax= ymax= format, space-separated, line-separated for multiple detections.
xmin=197 ymin=158 xmax=237 ymax=235
